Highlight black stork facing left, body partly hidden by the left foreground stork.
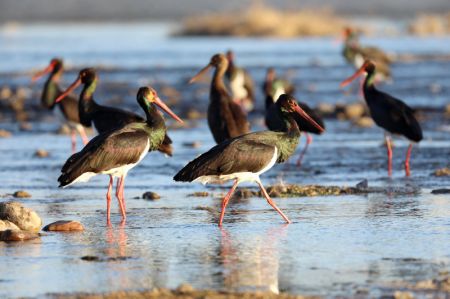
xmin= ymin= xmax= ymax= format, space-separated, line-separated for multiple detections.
xmin=56 ymin=68 xmax=173 ymax=156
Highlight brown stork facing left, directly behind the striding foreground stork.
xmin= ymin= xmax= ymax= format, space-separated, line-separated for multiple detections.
xmin=189 ymin=54 xmax=250 ymax=143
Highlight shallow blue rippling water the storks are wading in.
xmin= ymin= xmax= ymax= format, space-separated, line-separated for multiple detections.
xmin=0 ymin=25 xmax=450 ymax=297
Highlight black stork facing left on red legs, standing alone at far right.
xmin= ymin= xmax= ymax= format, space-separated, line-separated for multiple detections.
xmin=341 ymin=60 xmax=423 ymax=176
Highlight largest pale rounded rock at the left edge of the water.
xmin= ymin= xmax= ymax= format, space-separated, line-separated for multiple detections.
xmin=0 ymin=201 xmax=42 ymax=232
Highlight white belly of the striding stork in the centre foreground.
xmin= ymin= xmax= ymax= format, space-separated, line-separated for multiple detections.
xmin=194 ymin=146 xmax=278 ymax=185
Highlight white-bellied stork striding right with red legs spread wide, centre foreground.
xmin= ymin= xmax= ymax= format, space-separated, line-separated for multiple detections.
xmin=174 ymin=95 xmax=322 ymax=226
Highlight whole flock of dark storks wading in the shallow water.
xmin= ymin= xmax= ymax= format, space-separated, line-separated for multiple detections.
xmin=32 ymin=28 xmax=423 ymax=226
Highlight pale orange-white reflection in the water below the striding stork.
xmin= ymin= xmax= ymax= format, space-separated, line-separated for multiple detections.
xmin=219 ymin=224 xmax=287 ymax=294
